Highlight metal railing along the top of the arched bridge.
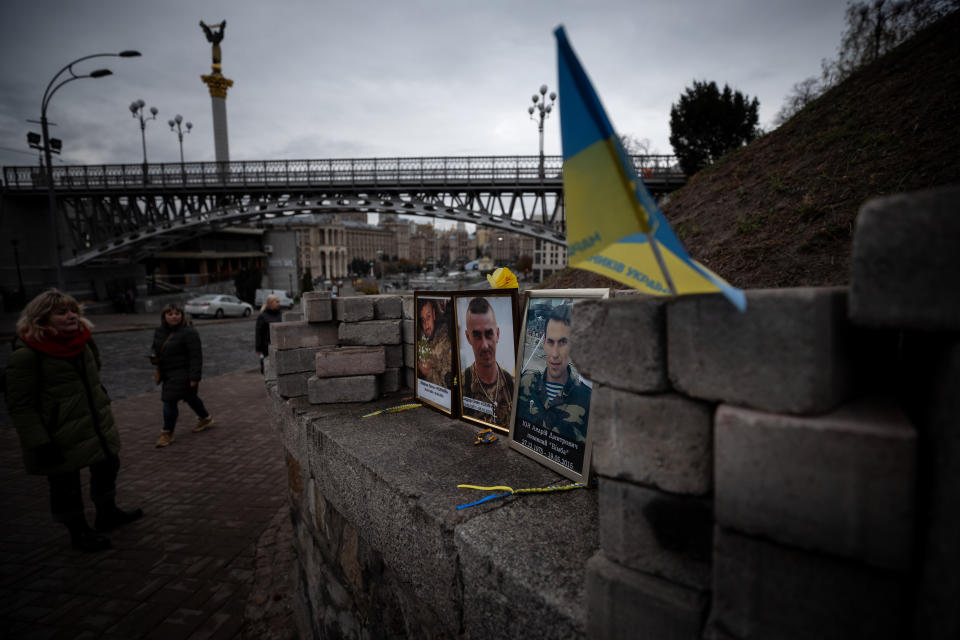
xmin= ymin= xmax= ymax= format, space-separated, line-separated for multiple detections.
xmin=3 ymin=155 xmax=686 ymax=191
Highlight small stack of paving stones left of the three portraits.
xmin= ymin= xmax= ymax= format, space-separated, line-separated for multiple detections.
xmin=264 ymin=292 xmax=404 ymax=404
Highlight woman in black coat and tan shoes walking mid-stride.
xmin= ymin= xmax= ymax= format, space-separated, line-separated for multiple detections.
xmin=150 ymin=302 xmax=213 ymax=447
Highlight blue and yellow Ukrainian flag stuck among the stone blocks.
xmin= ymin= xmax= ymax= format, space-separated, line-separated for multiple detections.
xmin=554 ymin=27 xmax=747 ymax=311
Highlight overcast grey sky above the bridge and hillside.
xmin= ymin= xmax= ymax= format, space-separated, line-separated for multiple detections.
xmin=0 ymin=0 xmax=844 ymax=170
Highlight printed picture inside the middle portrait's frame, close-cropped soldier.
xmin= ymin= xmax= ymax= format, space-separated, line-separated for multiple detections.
xmin=458 ymin=297 xmax=515 ymax=432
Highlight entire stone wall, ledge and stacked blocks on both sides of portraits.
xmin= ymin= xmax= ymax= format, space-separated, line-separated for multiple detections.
xmin=267 ymin=188 xmax=960 ymax=640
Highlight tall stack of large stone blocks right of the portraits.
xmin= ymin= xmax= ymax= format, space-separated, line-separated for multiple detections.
xmin=571 ymin=188 xmax=960 ymax=639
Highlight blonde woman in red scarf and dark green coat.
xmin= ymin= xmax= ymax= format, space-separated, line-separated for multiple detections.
xmin=6 ymin=289 xmax=143 ymax=551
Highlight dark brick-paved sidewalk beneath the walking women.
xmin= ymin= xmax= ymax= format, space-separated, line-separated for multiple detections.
xmin=0 ymin=368 xmax=296 ymax=640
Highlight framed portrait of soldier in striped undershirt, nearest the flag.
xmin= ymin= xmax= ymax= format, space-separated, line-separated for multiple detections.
xmin=509 ymin=289 xmax=610 ymax=482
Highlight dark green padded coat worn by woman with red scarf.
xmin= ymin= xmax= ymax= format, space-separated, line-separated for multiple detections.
xmin=6 ymin=339 xmax=120 ymax=475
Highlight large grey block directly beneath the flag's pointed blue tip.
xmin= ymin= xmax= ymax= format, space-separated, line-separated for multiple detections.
xmin=667 ymin=287 xmax=852 ymax=415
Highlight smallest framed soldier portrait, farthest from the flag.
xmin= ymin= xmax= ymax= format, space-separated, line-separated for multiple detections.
xmin=413 ymin=291 xmax=459 ymax=417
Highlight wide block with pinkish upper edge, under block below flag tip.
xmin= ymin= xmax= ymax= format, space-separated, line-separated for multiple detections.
xmin=715 ymin=400 xmax=917 ymax=569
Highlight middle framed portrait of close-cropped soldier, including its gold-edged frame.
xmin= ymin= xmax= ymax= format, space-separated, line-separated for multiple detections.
xmin=454 ymin=289 xmax=519 ymax=433
